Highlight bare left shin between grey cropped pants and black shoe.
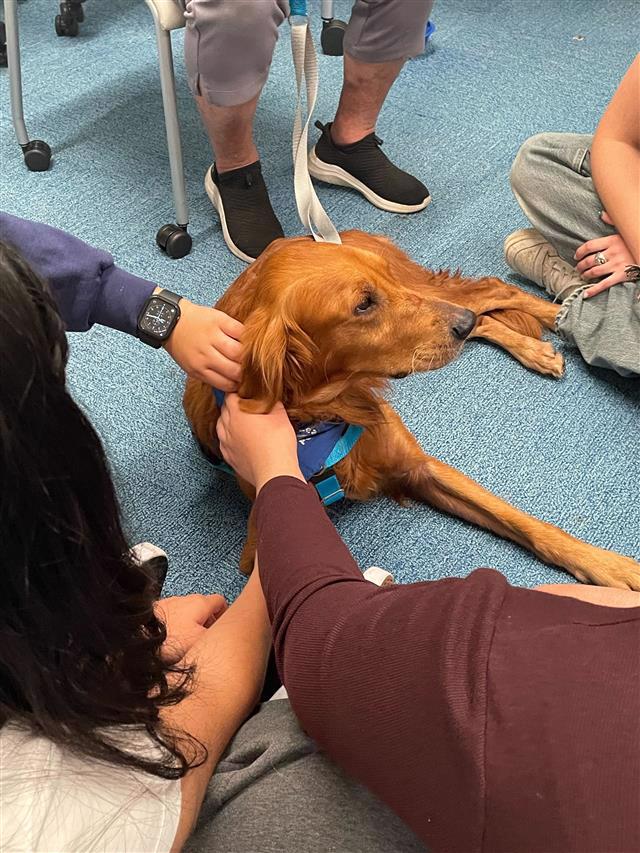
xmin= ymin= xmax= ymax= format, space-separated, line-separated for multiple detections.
xmin=195 ymin=94 xmax=260 ymax=172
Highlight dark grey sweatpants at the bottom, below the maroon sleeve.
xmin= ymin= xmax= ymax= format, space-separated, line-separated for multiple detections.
xmin=185 ymin=699 xmax=428 ymax=853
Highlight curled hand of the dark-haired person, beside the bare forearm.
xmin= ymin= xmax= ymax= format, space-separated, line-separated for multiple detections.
xmin=155 ymin=594 xmax=227 ymax=664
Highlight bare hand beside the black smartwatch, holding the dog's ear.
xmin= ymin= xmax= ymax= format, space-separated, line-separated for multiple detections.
xmin=163 ymin=299 xmax=244 ymax=391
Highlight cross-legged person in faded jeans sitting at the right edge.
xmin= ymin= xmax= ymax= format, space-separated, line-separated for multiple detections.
xmin=504 ymin=54 xmax=640 ymax=376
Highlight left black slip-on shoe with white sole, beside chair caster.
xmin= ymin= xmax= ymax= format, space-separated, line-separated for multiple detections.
xmin=204 ymin=160 xmax=284 ymax=263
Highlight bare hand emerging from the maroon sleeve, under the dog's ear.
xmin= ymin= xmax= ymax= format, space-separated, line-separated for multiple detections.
xmin=216 ymin=394 xmax=304 ymax=492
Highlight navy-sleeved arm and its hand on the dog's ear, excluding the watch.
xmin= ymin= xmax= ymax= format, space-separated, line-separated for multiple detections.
xmin=0 ymin=213 xmax=242 ymax=391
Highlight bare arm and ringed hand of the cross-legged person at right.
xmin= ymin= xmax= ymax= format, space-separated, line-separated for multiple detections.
xmin=575 ymin=55 xmax=640 ymax=297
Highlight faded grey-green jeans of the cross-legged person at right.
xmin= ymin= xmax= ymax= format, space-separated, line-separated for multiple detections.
xmin=511 ymin=133 xmax=640 ymax=376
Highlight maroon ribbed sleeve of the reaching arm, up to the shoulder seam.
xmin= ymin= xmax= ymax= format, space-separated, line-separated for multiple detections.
xmin=256 ymin=478 xmax=509 ymax=851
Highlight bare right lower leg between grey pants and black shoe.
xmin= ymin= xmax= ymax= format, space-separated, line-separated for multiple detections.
xmin=331 ymin=53 xmax=404 ymax=145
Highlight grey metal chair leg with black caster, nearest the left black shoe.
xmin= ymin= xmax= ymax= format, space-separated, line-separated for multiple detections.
xmin=149 ymin=13 xmax=192 ymax=258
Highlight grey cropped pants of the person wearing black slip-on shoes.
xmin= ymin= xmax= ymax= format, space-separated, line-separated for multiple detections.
xmin=183 ymin=0 xmax=433 ymax=107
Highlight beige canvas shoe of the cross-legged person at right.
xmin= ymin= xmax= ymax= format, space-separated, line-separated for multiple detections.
xmin=504 ymin=228 xmax=587 ymax=301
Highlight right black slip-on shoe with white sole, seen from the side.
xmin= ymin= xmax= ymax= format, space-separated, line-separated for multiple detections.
xmin=309 ymin=121 xmax=431 ymax=213
